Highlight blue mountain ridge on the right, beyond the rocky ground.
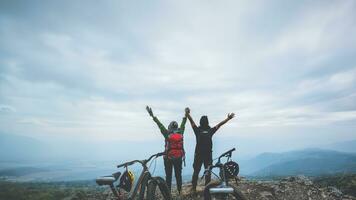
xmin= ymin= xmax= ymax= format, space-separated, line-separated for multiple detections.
xmin=241 ymin=149 xmax=356 ymax=177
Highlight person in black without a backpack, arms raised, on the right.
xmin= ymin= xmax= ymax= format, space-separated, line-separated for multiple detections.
xmin=186 ymin=108 xmax=235 ymax=192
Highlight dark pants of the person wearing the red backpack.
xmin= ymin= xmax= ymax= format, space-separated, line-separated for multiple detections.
xmin=164 ymin=158 xmax=182 ymax=193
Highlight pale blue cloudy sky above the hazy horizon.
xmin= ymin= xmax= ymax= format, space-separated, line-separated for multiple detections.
xmin=0 ymin=0 xmax=356 ymax=156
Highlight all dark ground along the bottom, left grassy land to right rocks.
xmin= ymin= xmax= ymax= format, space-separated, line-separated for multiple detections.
xmin=0 ymin=176 xmax=356 ymax=200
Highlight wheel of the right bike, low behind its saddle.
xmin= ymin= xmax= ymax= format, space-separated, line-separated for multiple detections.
xmin=204 ymin=182 xmax=247 ymax=200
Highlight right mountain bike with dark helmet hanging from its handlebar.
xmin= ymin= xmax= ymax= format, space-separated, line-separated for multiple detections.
xmin=203 ymin=148 xmax=247 ymax=200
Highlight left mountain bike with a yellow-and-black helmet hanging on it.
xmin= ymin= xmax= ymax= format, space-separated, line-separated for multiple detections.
xmin=96 ymin=153 xmax=172 ymax=200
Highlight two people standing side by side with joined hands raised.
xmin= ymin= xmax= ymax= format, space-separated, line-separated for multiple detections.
xmin=146 ymin=106 xmax=235 ymax=193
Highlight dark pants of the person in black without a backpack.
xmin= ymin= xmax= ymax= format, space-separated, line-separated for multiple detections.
xmin=192 ymin=154 xmax=213 ymax=189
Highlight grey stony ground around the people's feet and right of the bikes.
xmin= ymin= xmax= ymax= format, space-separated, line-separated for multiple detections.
xmin=156 ymin=176 xmax=356 ymax=200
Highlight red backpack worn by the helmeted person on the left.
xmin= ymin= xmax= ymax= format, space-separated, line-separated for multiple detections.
xmin=166 ymin=133 xmax=185 ymax=159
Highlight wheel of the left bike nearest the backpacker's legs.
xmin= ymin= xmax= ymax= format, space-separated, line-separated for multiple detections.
xmin=147 ymin=177 xmax=172 ymax=200
